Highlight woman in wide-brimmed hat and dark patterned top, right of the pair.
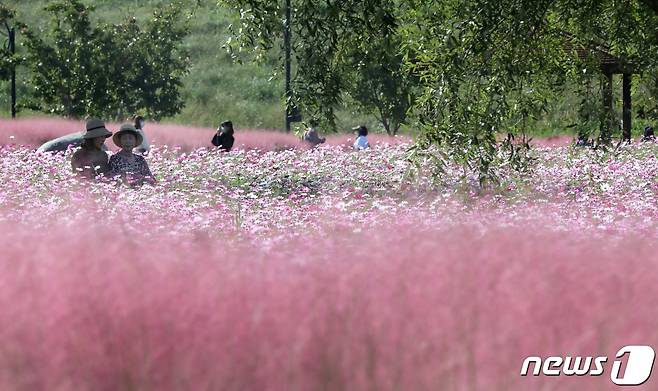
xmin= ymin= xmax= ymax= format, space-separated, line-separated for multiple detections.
xmin=110 ymin=124 xmax=155 ymax=185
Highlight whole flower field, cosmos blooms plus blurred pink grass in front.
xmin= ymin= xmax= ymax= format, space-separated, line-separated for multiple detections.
xmin=0 ymin=121 xmax=658 ymax=391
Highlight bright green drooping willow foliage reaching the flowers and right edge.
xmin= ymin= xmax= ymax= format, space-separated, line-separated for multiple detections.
xmin=399 ymin=0 xmax=657 ymax=179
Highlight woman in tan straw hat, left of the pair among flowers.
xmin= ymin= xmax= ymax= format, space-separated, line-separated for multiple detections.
xmin=71 ymin=118 xmax=112 ymax=179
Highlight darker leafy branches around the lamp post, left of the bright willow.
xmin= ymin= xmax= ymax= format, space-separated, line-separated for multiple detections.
xmin=219 ymin=0 xmax=411 ymax=134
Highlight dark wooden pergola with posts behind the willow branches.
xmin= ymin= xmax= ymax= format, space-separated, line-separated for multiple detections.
xmin=565 ymin=34 xmax=634 ymax=141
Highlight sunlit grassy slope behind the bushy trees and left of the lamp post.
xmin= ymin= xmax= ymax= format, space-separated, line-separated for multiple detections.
xmin=0 ymin=0 xmax=377 ymax=129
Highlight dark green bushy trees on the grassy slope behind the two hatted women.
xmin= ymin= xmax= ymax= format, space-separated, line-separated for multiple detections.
xmin=20 ymin=0 xmax=189 ymax=119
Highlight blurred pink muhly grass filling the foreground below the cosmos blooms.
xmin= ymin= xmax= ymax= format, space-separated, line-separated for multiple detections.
xmin=0 ymin=216 xmax=658 ymax=391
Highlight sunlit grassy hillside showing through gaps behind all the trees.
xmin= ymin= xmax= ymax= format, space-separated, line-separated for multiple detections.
xmin=0 ymin=0 xmax=658 ymax=136
